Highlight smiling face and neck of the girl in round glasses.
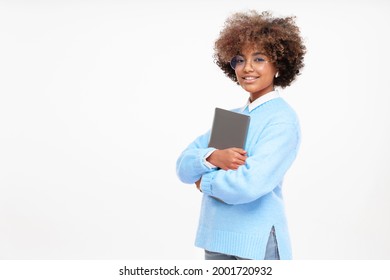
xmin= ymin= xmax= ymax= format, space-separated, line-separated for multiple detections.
xmin=231 ymin=47 xmax=277 ymax=102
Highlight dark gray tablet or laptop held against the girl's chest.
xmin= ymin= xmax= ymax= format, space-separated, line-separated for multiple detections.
xmin=209 ymin=108 xmax=250 ymax=150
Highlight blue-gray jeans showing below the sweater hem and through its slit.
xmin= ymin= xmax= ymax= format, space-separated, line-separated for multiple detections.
xmin=205 ymin=227 xmax=280 ymax=260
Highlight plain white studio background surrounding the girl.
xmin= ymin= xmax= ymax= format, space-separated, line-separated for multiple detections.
xmin=0 ymin=0 xmax=390 ymax=260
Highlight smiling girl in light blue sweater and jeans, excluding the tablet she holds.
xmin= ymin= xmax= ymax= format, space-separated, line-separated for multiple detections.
xmin=176 ymin=11 xmax=305 ymax=260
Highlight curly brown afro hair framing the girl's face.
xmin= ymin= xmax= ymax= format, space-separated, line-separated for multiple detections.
xmin=214 ymin=11 xmax=306 ymax=88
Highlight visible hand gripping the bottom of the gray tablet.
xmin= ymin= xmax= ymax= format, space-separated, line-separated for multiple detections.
xmin=206 ymin=148 xmax=247 ymax=170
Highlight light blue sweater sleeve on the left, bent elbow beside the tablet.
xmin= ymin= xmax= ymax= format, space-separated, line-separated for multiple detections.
xmin=176 ymin=131 xmax=215 ymax=184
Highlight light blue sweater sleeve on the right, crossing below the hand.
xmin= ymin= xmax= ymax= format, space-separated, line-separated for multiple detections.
xmin=201 ymin=123 xmax=300 ymax=204
